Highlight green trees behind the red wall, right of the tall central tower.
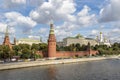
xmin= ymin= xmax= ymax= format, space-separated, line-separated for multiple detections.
xmin=57 ymin=43 xmax=120 ymax=55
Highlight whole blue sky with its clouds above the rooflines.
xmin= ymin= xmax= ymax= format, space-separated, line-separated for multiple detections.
xmin=0 ymin=0 xmax=120 ymax=43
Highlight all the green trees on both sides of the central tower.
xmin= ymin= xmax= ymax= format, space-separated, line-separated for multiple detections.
xmin=0 ymin=43 xmax=120 ymax=60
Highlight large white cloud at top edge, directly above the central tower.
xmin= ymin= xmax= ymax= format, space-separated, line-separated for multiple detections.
xmin=30 ymin=0 xmax=76 ymax=23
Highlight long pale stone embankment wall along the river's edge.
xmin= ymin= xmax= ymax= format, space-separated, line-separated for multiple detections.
xmin=0 ymin=56 xmax=118 ymax=70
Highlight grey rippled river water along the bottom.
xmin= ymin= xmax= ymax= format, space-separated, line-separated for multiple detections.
xmin=0 ymin=59 xmax=120 ymax=80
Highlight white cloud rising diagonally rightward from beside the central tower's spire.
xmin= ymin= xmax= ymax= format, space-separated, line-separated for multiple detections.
xmin=53 ymin=5 xmax=97 ymax=40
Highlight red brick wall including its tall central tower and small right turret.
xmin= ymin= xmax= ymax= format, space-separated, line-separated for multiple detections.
xmin=40 ymin=24 xmax=98 ymax=58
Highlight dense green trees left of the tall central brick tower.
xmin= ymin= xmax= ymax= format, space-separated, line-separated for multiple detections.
xmin=0 ymin=43 xmax=47 ymax=60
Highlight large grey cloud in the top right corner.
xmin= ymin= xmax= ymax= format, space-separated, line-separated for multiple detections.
xmin=99 ymin=0 xmax=120 ymax=22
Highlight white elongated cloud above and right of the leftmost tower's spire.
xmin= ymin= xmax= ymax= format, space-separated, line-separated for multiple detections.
xmin=5 ymin=12 xmax=37 ymax=32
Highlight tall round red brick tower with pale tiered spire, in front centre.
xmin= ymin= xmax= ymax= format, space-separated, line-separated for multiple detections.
xmin=48 ymin=23 xmax=56 ymax=58
